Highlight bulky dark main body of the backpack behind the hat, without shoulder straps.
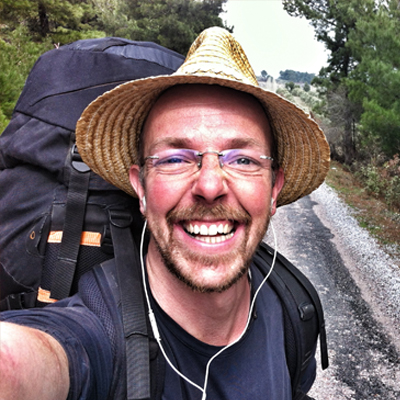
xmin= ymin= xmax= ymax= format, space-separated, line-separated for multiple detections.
xmin=0 ymin=38 xmax=184 ymax=310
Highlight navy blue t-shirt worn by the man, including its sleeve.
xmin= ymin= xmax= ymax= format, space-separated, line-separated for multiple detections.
xmin=1 ymin=262 xmax=315 ymax=400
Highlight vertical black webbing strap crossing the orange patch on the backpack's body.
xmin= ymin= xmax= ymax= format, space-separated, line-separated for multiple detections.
xmin=50 ymin=144 xmax=90 ymax=300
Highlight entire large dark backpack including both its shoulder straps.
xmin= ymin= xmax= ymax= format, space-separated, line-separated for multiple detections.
xmin=0 ymin=38 xmax=328 ymax=400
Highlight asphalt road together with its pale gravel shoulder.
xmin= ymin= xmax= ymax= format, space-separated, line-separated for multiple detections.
xmin=266 ymin=184 xmax=400 ymax=400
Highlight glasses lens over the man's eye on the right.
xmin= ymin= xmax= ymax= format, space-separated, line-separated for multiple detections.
xmin=220 ymin=149 xmax=269 ymax=174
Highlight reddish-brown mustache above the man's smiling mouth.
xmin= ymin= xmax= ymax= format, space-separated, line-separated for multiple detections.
xmin=166 ymin=203 xmax=251 ymax=225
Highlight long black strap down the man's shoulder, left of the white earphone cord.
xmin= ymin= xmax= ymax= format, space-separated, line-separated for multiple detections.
xmin=109 ymin=210 xmax=151 ymax=400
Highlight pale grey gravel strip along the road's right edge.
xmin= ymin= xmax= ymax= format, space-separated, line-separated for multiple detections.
xmin=311 ymin=183 xmax=400 ymax=350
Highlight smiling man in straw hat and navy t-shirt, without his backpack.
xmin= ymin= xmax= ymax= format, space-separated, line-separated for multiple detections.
xmin=0 ymin=28 xmax=329 ymax=400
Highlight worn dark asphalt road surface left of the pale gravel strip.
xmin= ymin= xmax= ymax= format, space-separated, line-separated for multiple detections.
xmin=267 ymin=187 xmax=400 ymax=400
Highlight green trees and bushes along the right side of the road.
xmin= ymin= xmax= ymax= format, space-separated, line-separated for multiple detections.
xmin=283 ymin=0 xmax=400 ymax=211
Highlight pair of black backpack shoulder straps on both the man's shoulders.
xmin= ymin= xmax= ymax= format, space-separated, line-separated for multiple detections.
xmin=94 ymin=237 xmax=329 ymax=400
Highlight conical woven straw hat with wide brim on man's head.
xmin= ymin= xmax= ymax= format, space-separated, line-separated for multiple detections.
xmin=76 ymin=27 xmax=330 ymax=206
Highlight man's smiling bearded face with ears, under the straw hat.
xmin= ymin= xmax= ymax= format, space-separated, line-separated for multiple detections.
xmin=131 ymin=85 xmax=283 ymax=292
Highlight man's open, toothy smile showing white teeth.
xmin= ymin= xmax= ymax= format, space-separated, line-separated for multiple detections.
xmin=183 ymin=221 xmax=235 ymax=244
